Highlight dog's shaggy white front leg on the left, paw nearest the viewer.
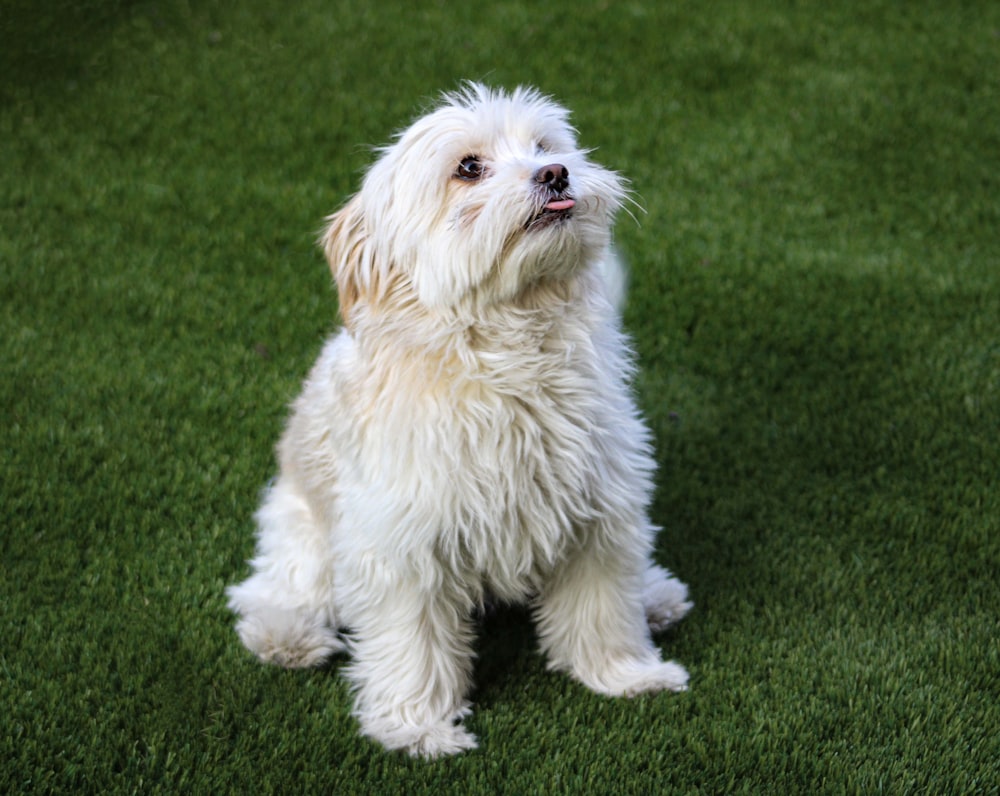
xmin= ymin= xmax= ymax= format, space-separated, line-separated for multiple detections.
xmin=346 ymin=561 xmax=476 ymax=757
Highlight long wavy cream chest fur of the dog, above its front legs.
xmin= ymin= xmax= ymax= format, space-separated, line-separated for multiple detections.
xmin=368 ymin=330 xmax=615 ymax=582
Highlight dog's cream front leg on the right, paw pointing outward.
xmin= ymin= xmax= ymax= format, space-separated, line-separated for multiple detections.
xmin=536 ymin=545 xmax=688 ymax=696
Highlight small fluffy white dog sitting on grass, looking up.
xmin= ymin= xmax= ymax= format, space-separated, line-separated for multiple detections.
xmin=228 ymin=84 xmax=691 ymax=757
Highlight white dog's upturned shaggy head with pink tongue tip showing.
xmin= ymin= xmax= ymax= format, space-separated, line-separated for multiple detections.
xmin=323 ymin=85 xmax=625 ymax=324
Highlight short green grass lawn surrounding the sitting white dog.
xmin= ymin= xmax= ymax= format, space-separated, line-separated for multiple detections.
xmin=0 ymin=0 xmax=1000 ymax=794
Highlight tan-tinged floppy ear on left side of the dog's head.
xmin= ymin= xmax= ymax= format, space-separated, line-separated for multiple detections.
xmin=319 ymin=195 xmax=376 ymax=328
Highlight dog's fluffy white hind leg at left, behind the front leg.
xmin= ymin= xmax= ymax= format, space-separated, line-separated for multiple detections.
xmin=226 ymin=479 xmax=344 ymax=667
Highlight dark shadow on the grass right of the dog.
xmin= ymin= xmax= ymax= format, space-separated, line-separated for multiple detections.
xmin=640 ymin=262 xmax=924 ymax=606
